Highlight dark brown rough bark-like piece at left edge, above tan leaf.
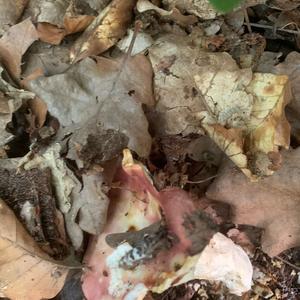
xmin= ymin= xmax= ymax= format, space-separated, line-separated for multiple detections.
xmin=0 ymin=159 xmax=67 ymax=258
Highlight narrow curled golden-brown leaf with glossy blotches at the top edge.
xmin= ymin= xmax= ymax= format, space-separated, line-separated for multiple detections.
xmin=70 ymin=0 xmax=136 ymax=62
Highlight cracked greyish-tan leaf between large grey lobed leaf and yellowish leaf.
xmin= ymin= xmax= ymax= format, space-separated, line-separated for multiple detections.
xmin=149 ymin=35 xmax=207 ymax=136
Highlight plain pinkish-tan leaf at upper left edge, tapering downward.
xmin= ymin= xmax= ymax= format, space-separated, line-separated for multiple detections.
xmin=0 ymin=19 xmax=38 ymax=80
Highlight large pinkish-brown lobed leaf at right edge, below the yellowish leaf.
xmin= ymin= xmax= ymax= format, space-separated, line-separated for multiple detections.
xmin=207 ymin=148 xmax=300 ymax=256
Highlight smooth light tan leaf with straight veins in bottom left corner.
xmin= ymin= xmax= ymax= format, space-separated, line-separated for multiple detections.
xmin=0 ymin=200 xmax=68 ymax=300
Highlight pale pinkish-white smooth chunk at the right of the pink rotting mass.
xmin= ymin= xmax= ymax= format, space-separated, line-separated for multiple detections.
xmin=194 ymin=233 xmax=253 ymax=296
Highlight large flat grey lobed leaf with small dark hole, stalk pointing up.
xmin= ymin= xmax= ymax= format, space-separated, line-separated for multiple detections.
xmin=29 ymin=55 xmax=153 ymax=159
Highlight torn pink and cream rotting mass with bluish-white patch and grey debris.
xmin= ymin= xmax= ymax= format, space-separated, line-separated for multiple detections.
xmin=83 ymin=150 xmax=225 ymax=299
